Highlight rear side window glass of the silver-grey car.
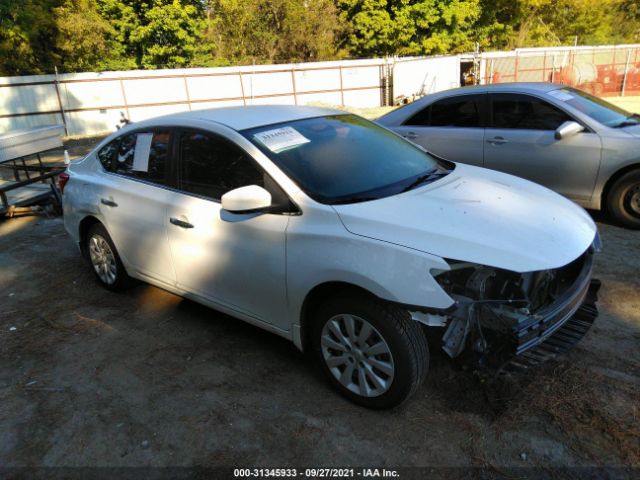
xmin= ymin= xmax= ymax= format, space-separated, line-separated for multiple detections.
xmin=405 ymin=95 xmax=485 ymax=128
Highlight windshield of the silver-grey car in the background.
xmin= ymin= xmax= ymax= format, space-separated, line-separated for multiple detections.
xmin=549 ymin=87 xmax=640 ymax=128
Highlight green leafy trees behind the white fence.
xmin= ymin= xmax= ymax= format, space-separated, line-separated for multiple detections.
xmin=0 ymin=0 xmax=640 ymax=75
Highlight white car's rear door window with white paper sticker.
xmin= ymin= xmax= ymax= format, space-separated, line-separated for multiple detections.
xmin=115 ymin=130 xmax=171 ymax=185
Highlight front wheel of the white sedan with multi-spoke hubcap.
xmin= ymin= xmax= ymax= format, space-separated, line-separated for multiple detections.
xmin=312 ymin=295 xmax=429 ymax=409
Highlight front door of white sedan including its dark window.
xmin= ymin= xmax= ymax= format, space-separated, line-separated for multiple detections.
xmin=165 ymin=130 xmax=289 ymax=330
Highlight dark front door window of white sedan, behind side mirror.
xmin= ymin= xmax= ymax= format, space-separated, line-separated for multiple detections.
xmin=180 ymin=131 xmax=289 ymax=205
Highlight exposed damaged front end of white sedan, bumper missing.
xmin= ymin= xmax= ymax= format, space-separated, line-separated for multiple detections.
xmin=412 ymin=246 xmax=600 ymax=370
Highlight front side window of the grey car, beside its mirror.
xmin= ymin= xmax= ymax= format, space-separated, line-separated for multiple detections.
xmin=491 ymin=93 xmax=573 ymax=130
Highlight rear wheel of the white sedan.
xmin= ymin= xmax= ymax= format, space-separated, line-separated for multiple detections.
xmin=85 ymin=224 xmax=131 ymax=291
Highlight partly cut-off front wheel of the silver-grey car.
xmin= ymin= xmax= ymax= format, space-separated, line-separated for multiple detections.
xmin=607 ymin=170 xmax=640 ymax=229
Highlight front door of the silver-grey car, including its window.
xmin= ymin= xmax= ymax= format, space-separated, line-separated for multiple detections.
xmin=484 ymin=93 xmax=601 ymax=201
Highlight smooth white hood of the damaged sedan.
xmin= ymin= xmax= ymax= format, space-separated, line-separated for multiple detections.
xmin=334 ymin=164 xmax=597 ymax=272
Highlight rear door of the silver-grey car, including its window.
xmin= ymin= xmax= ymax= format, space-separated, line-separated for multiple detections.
xmin=396 ymin=94 xmax=486 ymax=166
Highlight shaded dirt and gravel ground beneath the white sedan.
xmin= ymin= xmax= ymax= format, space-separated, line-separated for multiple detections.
xmin=0 ymin=209 xmax=640 ymax=478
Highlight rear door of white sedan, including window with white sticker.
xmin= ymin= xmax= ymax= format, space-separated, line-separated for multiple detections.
xmin=97 ymin=128 xmax=176 ymax=285
